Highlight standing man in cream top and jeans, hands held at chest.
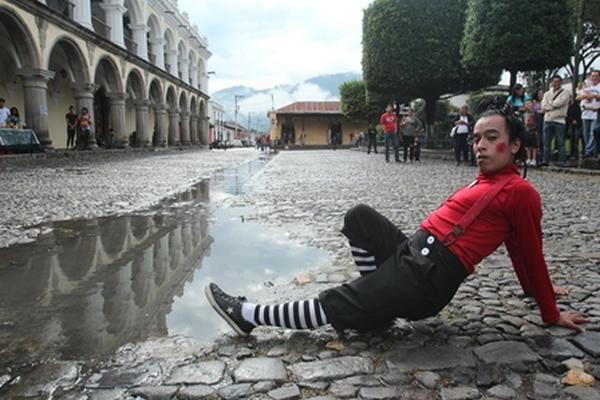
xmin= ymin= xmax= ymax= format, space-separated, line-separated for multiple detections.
xmin=542 ymin=75 xmax=571 ymax=167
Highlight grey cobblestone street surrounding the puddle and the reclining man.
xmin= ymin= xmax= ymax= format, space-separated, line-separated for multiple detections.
xmin=0 ymin=151 xmax=600 ymax=400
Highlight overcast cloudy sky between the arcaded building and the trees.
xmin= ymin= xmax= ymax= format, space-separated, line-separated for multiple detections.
xmin=179 ymin=0 xmax=371 ymax=92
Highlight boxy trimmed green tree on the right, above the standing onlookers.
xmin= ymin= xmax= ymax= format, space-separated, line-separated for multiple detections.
xmin=461 ymin=0 xmax=574 ymax=87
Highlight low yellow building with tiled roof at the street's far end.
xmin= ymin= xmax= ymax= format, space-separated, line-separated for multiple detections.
xmin=269 ymin=101 xmax=367 ymax=148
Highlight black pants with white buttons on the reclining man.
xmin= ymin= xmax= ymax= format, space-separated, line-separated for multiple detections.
xmin=319 ymin=205 xmax=467 ymax=330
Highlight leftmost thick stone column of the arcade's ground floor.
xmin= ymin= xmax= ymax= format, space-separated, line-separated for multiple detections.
xmin=17 ymin=69 xmax=54 ymax=149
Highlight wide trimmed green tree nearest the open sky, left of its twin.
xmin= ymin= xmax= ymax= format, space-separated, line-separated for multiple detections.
xmin=362 ymin=0 xmax=501 ymax=131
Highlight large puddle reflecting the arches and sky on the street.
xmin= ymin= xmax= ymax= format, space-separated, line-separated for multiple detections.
xmin=0 ymin=161 xmax=327 ymax=372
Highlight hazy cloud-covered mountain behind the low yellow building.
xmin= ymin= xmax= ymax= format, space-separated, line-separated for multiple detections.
xmin=211 ymin=72 xmax=362 ymax=131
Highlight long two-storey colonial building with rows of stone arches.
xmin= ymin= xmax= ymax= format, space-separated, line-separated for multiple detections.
xmin=0 ymin=0 xmax=211 ymax=148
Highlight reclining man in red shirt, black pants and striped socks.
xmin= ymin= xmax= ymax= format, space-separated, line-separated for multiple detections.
xmin=206 ymin=106 xmax=589 ymax=335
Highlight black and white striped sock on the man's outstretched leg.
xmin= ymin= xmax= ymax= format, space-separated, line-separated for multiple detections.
xmin=242 ymin=299 xmax=329 ymax=329
